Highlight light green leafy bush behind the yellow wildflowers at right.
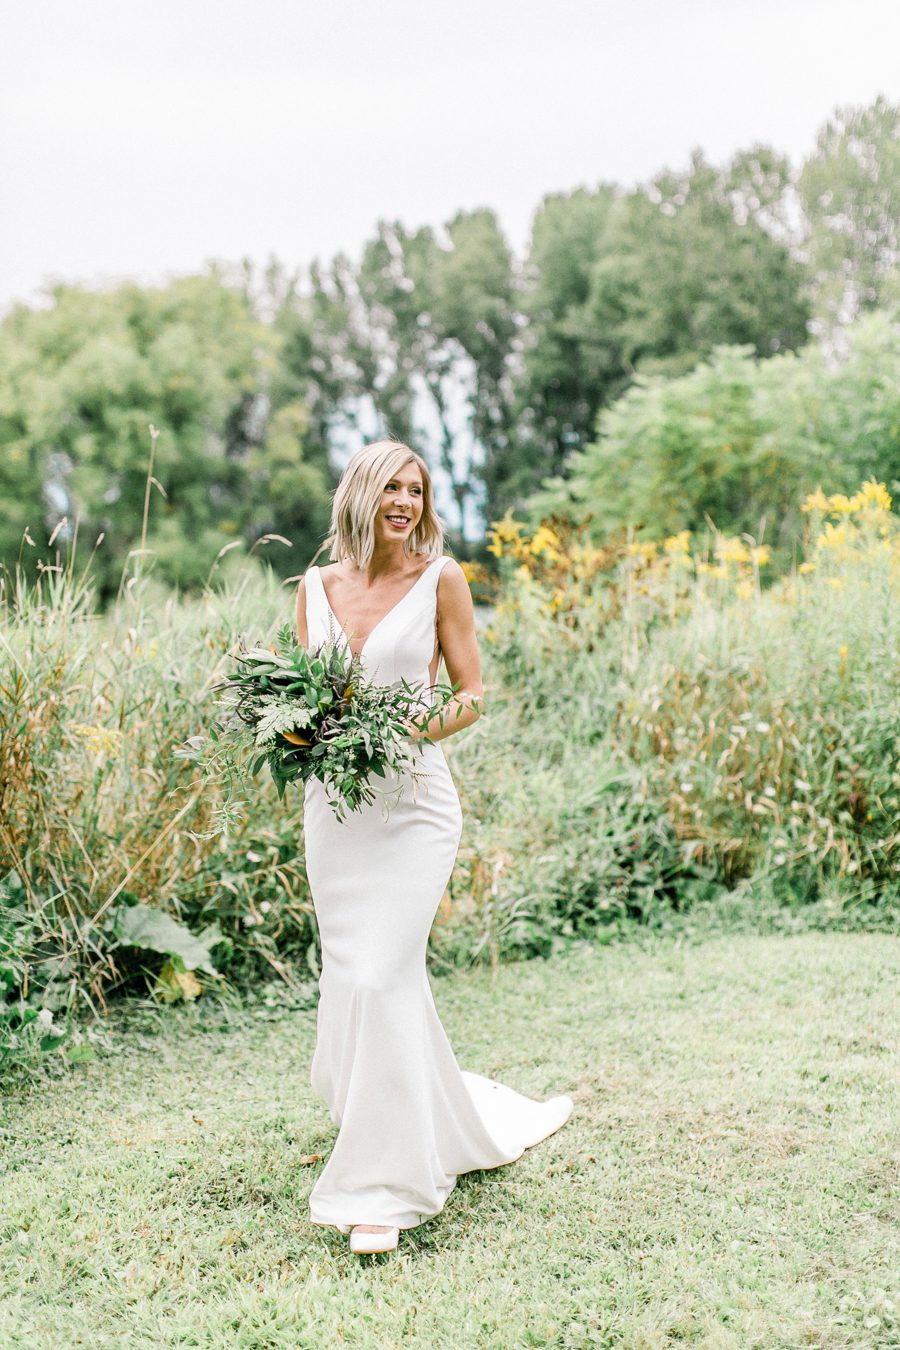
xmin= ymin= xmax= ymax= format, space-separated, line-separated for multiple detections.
xmin=529 ymin=313 xmax=900 ymax=567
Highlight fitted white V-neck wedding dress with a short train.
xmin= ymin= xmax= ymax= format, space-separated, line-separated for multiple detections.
xmin=304 ymin=558 xmax=572 ymax=1231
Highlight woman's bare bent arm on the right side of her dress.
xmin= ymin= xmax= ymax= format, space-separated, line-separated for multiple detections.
xmin=413 ymin=559 xmax=484 ymax=741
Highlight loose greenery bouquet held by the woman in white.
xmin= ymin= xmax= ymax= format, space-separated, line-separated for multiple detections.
xmin=184 ymin=624 xmax=456 ymax=833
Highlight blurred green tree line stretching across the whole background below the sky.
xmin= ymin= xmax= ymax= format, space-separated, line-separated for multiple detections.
xmin=0 ymin=99 xmax=900 ymax=594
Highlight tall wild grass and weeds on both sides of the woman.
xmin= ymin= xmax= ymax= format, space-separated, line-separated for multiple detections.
xmin=0 ymin=485 xmax=900 ymax=1080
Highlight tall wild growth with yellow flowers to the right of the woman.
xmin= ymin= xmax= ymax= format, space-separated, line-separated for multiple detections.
xmin=455 ymin=483 xmax=900 ymax=959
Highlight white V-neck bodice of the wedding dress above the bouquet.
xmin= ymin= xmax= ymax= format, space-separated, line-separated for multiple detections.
xmin=305 ymin=555 xmax=449 ymax=687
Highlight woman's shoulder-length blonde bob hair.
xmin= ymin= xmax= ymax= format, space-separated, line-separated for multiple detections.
xmin=325 ymin=440 xmax=444 ymax=568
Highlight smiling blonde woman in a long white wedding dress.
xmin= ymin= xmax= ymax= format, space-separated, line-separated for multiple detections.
xmin=297 ymin=441 xmax=572 ymax=1253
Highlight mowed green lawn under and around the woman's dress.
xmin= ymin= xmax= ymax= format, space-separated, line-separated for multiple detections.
xmin=0 ymin=934 xmax=900 ymax=1350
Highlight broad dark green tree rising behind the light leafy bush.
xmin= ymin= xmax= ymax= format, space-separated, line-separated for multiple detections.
xmin=486 ymin=154 xmax=808 ymax=514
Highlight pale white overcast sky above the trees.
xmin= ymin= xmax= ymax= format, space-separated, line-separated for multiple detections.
xmin=0 ymin=0 xmax=900 ymax=308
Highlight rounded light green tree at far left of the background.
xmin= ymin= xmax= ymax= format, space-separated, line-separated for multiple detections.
xmin=0 ymin=273 xmax=327 ymax=597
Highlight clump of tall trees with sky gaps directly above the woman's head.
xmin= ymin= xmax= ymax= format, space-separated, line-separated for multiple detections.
xmin=281 ymin=211 xmax=517 ymax=535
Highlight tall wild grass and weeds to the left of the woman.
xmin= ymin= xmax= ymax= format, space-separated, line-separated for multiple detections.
xmin=0 ymin=548 xmax=314 ymax=1074
